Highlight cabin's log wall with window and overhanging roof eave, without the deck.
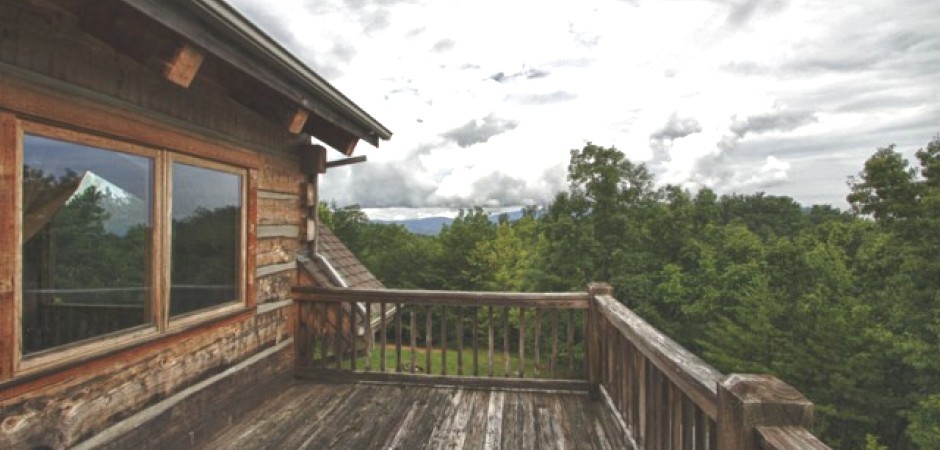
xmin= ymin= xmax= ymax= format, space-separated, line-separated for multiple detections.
xmin=0 ymin=0 xmax=391 ymax=448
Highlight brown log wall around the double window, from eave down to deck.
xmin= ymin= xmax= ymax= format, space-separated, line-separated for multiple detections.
xmin=0 ymin=0 xmax=304 ymax=448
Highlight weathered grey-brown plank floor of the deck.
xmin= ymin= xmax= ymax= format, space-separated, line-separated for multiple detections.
xmin=204 ymin=381 xmax=629 ymax=449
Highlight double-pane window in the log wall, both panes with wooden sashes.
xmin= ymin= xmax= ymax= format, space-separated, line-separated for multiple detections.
xmin=19 ymin=124 xmax=247 ymax=361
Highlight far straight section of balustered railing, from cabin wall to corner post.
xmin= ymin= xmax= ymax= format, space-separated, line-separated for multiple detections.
xmin=294 ymin=287 xmax=589 ymax=387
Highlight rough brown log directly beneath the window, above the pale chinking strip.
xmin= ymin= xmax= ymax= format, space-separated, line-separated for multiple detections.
xmin=0 ymin=308 xmax=292 ymax=448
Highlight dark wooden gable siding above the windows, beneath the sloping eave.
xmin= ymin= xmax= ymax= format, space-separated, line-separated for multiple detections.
xmin=0 ymin=0 xmax=296 ymax=158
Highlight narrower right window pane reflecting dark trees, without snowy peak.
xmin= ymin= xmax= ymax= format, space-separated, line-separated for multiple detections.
xmin=170 ymin=163 xmax=242 ymax=317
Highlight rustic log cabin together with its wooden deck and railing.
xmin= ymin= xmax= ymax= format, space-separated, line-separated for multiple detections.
xmin=0 ymin=0 xmax=827 ymax=450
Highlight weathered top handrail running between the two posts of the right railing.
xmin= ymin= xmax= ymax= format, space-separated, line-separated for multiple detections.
xmin=594 ymin=295 xmax=725 ymax=419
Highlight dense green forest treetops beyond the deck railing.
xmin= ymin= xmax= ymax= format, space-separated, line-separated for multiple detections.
xmin=320 ymin=137 xmax=940 ymax=449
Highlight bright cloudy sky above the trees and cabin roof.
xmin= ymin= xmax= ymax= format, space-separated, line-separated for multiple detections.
xmin=229 ymin=0 xmax=940 ymax=219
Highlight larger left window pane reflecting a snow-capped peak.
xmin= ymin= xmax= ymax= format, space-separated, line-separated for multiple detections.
xmin=22 ymin=135 xmax=153 ymax=355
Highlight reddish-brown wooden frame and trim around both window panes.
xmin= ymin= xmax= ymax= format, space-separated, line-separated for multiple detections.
xmin=0 ymin=118 xmax=257 ymax=376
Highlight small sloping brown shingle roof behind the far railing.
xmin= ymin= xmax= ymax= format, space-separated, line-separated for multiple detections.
xmin=301 ymin=224 xmax=385 ymax=289
